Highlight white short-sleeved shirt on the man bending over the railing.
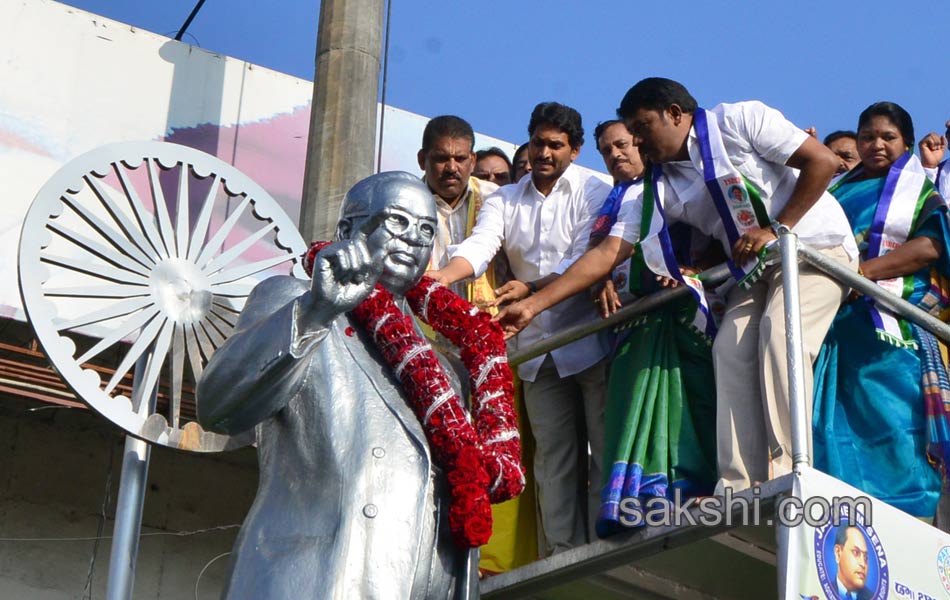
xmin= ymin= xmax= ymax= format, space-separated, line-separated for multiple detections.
xmin=610 ymin=101 xmax=858 ymax=258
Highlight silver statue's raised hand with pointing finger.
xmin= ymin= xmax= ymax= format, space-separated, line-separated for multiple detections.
xmin=311 ymin=237 xmax=383 ymax=314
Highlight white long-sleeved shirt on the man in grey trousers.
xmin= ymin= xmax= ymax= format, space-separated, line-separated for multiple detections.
xmin=450 ymin=165 xmax=610 ymax=381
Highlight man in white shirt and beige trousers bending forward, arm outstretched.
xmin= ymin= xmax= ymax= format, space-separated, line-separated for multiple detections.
xmin=499 ymin=78 xmax=857 ymax=493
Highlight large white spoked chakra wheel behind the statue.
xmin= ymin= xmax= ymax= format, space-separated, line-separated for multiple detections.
xmin=19 ymin=142 xmax=307 ymax=452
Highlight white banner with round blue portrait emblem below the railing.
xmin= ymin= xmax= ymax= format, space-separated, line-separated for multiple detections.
xmin=783 ymin=469 xmax=950 ymax=600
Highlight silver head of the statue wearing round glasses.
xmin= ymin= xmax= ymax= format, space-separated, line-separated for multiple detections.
xmin=354 ymin=181 xmax=438 ymax=295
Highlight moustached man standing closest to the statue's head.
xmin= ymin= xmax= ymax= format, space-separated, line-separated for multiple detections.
xmin=416 ymin=115 xmax=498 ymax=308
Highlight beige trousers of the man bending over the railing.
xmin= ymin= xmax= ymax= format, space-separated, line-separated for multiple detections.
xmin=713 ymin=246 xmax=858 ymax=494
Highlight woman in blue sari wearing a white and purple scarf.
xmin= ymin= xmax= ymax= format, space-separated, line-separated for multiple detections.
xmin=814 ymin=102 xmax=950 ymax=518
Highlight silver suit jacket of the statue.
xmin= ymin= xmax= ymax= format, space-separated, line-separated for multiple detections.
xmin=198 ymin=277 xmax=477 ymax=600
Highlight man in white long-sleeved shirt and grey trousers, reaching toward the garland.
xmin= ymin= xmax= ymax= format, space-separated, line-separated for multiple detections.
xmin=430 ymin=102 xmax=610 ymax=554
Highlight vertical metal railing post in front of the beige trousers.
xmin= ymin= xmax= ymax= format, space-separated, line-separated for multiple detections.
xmin=778 ymin=231 xmax=811 ymax=473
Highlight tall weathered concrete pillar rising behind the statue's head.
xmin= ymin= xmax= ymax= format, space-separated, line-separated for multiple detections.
xmin=300 ymin=0 xmax=384 ymax=241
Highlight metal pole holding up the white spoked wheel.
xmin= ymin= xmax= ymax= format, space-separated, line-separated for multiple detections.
xmin=106 ymin=352 xmax=158 ymax=600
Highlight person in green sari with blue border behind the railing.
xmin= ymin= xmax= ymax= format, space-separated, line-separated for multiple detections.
xmin=588 ymin=173 xmax=716 ymax=537
